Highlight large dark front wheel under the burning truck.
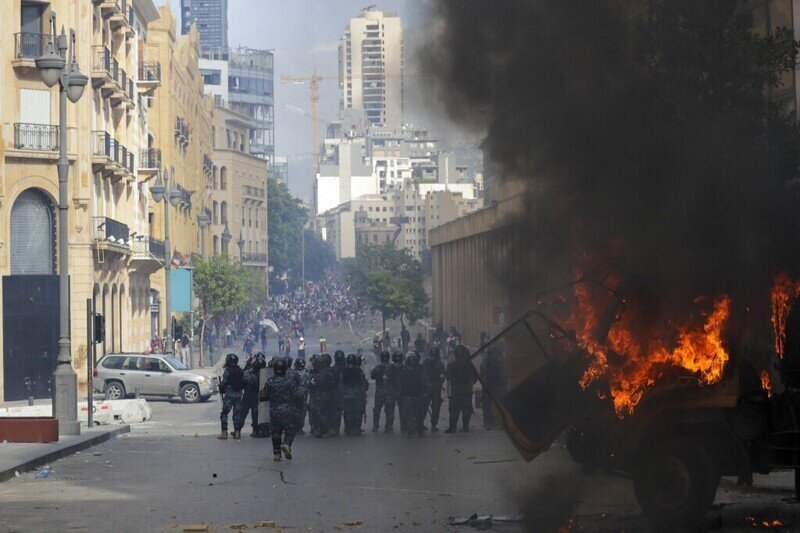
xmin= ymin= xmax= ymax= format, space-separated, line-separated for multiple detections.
xmin=633 ymin=436 xmax=720 ymax=527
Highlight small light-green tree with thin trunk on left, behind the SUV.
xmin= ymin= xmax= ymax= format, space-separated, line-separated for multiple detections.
xmin=194 ymin=255 xmax=248 ymax=361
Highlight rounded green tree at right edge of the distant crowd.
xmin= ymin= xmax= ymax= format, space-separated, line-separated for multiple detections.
xmin=343 ymin=244 xmax=428 ymax=331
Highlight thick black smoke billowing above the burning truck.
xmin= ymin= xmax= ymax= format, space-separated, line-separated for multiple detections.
xmin=420 ymin=0 xmax=800 ymax=344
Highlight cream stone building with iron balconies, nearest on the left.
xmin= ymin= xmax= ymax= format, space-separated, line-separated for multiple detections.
xmin=0 ymin=0 xmax=159 ymax=400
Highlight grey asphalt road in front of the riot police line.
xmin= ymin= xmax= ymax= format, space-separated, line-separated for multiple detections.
xmin=0 ymin=324 xmax=800 ymax=532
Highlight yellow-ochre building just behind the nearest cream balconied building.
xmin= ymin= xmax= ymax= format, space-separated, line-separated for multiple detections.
xmin=143 ymin=5 xmax=214 ymax=344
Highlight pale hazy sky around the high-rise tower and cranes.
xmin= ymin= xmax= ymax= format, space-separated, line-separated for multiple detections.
xmin=169 ymin=0 xmax=472 ymax=198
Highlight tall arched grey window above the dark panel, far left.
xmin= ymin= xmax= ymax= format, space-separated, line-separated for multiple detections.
xmin=11 ymin=189 xmax=56 ymax=275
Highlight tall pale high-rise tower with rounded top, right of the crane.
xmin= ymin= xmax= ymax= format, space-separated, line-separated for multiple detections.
xmin=339 ymin=8 xmax=403 ymax=128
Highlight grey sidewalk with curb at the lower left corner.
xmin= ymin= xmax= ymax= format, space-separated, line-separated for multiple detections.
xmin=0 ymin=425 xmax=131 ymax=482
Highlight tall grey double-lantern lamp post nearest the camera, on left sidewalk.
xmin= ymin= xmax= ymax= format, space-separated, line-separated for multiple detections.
xmin=36 ymin=13 xmax=89 ymax=435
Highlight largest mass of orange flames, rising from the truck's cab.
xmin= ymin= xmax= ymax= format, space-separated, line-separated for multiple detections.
xmin=573 ymin=278 xmax=731 ymax=417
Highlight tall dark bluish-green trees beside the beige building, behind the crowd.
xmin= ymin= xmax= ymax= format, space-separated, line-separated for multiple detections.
xmin=268 ymin=178 xmax=336 ymax=286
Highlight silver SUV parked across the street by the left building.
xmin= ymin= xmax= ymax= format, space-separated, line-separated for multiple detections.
xmin=94 ymin=354 xmax=217 ymax=403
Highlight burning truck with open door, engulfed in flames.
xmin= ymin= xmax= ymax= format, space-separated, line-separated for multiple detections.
xmin=473 ymin=268 xmax=800 ymax=526
